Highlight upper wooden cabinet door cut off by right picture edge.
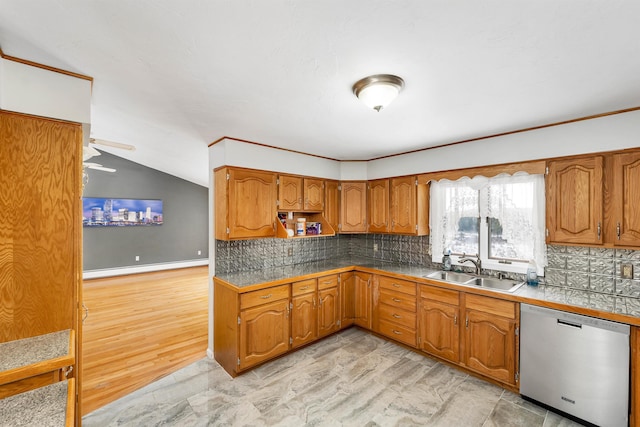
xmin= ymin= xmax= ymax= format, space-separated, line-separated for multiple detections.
xmin=607 ymin=152 xmax=640 ymax=246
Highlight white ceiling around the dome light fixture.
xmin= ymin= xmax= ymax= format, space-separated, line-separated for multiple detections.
xmin=0 ymin=0 xmax=640 ymax=185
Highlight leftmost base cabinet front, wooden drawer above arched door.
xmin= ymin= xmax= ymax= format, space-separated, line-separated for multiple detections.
xmin=238 ymin=285 xmax=290 ymax=369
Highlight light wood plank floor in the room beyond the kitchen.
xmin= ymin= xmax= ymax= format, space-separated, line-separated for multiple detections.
xmin=81 ymin=266 xmax=208 ymax=415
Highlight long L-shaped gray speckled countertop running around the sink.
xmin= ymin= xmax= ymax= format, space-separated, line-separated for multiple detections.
xmin=216 ymin=258 xmax=640 ymax=326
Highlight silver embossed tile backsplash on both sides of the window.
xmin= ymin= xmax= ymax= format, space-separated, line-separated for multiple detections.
xmin=215 ymin=234 xmax=640 ymax=298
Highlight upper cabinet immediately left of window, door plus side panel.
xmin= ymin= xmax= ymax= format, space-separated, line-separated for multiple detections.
xmin=389 ymin=176 xmax=429 ymax=236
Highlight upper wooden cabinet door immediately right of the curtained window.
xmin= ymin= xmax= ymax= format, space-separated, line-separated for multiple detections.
xmin=546 ymin=156 xmax=603 ymax=244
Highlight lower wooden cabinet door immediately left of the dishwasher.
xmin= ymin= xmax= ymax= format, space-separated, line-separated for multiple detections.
xmin=464 ymin=310 xmax=516 ymax=385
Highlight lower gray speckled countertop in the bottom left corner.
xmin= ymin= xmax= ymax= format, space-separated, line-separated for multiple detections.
xmin=0 ymin=381 xmax=68 ymax=427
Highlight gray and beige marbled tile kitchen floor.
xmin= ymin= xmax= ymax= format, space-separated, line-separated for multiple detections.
xmin=83 ymin=328 xmax=579 ymax=427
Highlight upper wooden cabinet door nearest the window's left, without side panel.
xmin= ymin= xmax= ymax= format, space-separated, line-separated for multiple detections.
xmin=391 ymin=176 xmax=417 ymax=234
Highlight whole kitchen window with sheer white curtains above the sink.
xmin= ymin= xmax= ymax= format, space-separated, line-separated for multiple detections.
xmin=430 ymin=173 xmax=546 ymax=274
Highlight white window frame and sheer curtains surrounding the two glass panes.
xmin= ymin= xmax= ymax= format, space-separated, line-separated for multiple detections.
xmin=429 ymin=172 xmax=547 ymax=275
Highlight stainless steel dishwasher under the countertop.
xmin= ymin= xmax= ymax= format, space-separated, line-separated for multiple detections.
xmin=520 ymin=304 xmax=630 ymax=426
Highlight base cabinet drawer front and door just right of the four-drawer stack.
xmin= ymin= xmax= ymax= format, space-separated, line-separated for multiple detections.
xmin=418 ymin=285 xmax=461 ymax=363
